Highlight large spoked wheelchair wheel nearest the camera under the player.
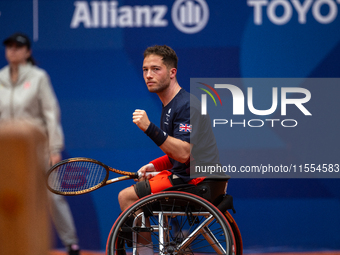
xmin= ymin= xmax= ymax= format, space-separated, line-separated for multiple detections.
xmin=106 ymin=191 xmax=235 ymax=255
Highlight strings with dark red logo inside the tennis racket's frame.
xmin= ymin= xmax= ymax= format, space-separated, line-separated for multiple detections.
xmin=48 ymin=161 xmax=107 ymax=192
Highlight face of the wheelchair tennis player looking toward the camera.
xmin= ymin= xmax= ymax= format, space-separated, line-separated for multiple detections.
xmin=143 ymin=55 xmax=170 ymax=93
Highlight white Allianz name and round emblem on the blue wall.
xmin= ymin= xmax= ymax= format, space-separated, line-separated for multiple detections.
xmin=70 ymin=0 xmax=209 ymax=34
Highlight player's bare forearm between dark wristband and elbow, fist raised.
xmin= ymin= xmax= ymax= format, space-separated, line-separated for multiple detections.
xmin=160 ymin=136 xmax=190 ymax=163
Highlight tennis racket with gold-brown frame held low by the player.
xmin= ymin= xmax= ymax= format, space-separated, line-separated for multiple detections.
xmin=47 ymin=158 xmax=159 ymax=196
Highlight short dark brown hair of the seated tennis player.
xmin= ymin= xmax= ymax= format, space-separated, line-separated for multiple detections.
xmin=144 ymin=45 xmax=178 ymax=69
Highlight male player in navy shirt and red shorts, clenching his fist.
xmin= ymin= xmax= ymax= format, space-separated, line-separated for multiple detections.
xmin=118 ymin=45 xmax=234 ymax=254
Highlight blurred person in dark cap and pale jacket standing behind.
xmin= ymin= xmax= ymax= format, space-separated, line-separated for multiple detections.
xmin=0 ymin=33 xmax=79 ymax=255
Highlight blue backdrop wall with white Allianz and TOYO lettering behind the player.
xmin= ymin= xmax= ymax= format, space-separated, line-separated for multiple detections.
xmin=0 ymin=0 xmax=340 ymax=252
